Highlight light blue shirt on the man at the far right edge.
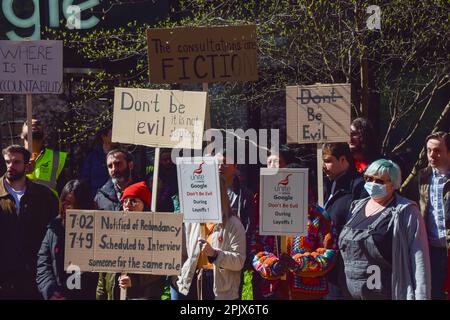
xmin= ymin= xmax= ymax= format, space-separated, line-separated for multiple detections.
xmin=427 ymin=168 xmax=450 ymax=247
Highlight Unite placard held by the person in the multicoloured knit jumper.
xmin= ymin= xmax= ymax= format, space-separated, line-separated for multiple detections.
xmin=259 ymin=168 xmax=308 ymax=236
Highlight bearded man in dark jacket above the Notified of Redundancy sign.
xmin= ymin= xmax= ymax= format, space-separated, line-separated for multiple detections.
xmin=95 ymin=149 xmax=134 ymax=211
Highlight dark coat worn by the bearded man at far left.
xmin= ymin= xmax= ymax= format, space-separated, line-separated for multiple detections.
xmin=0 ymin=177 xmax=58 ymax=300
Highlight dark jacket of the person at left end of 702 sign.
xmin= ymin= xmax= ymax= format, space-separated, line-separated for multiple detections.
xmin=36 ymin=217 xmax=98 ymax=300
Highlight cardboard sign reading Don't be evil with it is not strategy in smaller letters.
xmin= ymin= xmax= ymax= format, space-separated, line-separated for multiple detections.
xmin=112 ymin=88 xmax=207 ymax=149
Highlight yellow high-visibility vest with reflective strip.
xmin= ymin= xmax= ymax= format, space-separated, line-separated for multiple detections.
xmin=27 ymin=148 xmax=67 ymax=196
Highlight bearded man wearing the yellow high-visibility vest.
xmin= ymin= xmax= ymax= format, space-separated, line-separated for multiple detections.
xmin=21 ymin=119 xmax=67 ymax=197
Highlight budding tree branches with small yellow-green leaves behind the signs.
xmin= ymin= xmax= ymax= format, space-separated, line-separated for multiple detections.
xmin=49 ymin=0 xmax=450 ymax=158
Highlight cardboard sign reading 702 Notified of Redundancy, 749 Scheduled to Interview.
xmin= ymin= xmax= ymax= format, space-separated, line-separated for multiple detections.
xmin=64 ymin=210 xmax=183 ymax=275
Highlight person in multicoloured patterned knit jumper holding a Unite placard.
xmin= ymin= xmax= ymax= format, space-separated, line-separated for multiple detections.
xmin=253 ymin=163 xmax=337 ymax=300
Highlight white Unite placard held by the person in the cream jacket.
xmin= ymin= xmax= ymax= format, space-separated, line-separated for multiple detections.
xmin=177 ymin=157 xmax=222 ymax=223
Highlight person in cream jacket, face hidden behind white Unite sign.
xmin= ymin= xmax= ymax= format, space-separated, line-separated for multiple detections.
xmin=177 ymin=177 xmax=246 ymax=300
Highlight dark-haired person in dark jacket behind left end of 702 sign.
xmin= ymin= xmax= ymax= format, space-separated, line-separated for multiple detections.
xmin=36 ymin=180 xmax=97 ymax=300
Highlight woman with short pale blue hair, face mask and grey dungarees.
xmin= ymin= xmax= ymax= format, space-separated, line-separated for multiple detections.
xmin=339 ymin=159 xmax=431 ymax=300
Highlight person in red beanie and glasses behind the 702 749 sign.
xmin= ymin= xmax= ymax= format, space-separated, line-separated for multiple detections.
xmin=97 ymin=181 xmax=166 ymax=300
